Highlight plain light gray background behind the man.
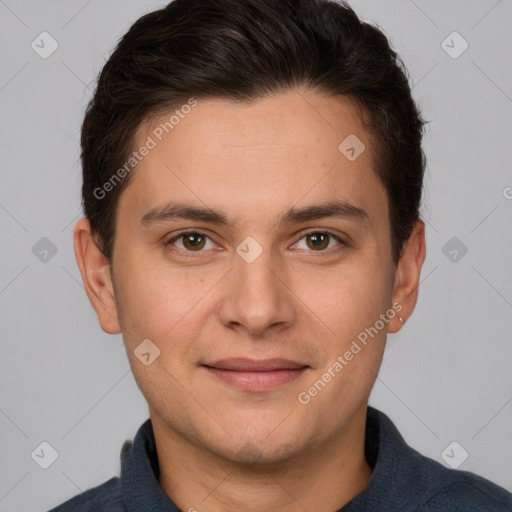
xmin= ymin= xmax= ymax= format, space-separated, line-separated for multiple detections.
xmin=0 ymin=0 xmax=512 ymax=512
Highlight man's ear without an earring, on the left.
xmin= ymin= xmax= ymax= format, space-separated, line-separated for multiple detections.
xmin=74 ymin=217 xmax=121 ymax=334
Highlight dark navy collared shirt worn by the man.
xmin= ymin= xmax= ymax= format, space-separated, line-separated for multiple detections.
xmin=50 ymin=407 xmax=512 ymax=512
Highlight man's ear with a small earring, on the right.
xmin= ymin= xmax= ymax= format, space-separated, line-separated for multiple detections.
xmin=388 ymin=220 xmax=426 ymax=333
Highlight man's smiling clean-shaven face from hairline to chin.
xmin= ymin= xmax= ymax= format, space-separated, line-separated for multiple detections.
xmin=74 ymin=90 xmax=422 ymax=462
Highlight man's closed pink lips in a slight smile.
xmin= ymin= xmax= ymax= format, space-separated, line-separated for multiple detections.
xmin=202 ymin=358 xmax=310 ymax=392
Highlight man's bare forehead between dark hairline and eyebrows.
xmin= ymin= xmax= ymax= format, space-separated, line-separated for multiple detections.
xmin=120 ymin=90 xmax=387 ymax=228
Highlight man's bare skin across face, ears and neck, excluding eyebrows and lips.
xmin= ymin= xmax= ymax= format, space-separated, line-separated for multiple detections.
xmin=74 ymin=89 xmax=425 ymax=512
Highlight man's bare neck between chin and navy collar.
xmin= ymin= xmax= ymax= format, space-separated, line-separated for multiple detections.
xmin=152 ymin=409 xmax=372 ymax=512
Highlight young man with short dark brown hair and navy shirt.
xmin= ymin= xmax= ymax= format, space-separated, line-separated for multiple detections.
xmin=50 ymin=0 xmax=512 ymax=512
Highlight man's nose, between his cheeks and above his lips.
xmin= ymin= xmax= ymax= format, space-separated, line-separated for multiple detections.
xmin=218 ymin=246 xmax=296 ymax=338
